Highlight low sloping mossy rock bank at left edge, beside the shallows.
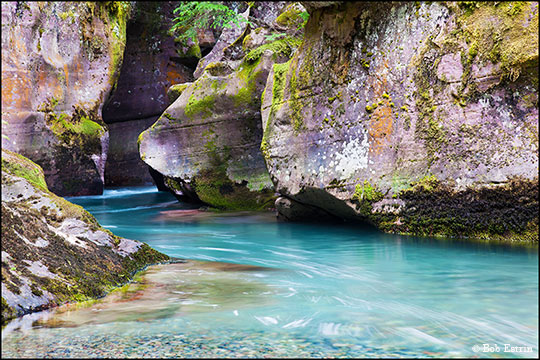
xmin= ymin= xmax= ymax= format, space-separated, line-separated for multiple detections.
xmin=2 ymin=150 xmax=168 ymax=322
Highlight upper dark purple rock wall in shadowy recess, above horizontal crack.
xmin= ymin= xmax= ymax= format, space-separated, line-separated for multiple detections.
xmin=103 ymin=1 xmax=193 ymax=123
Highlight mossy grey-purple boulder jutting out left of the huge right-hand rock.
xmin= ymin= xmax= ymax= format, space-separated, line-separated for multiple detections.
xmin=139 ymin=3 xmax=303 ymax=209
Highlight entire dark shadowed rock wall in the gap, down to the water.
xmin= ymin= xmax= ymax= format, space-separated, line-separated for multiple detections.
xmin=103 ymin=1 xmax=193 ymax=186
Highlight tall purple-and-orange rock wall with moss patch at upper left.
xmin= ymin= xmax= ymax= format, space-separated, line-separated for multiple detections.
xmin=2 ymin=2 xmax=130 ymax=196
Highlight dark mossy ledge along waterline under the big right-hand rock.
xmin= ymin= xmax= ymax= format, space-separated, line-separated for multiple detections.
xmin=368 ymin=176 xmax=539 ymax=245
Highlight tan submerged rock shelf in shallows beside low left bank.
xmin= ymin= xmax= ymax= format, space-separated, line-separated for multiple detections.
xmin=25 ymin=260 xmax=277 ymax=327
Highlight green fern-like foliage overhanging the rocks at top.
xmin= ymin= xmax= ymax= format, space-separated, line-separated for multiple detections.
xmin=171 ymin=1 xmax=247 ymax=43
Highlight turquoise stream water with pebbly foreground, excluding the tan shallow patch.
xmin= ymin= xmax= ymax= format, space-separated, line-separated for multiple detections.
xmin=2 ymin=187 xmax=538 ymax=357
